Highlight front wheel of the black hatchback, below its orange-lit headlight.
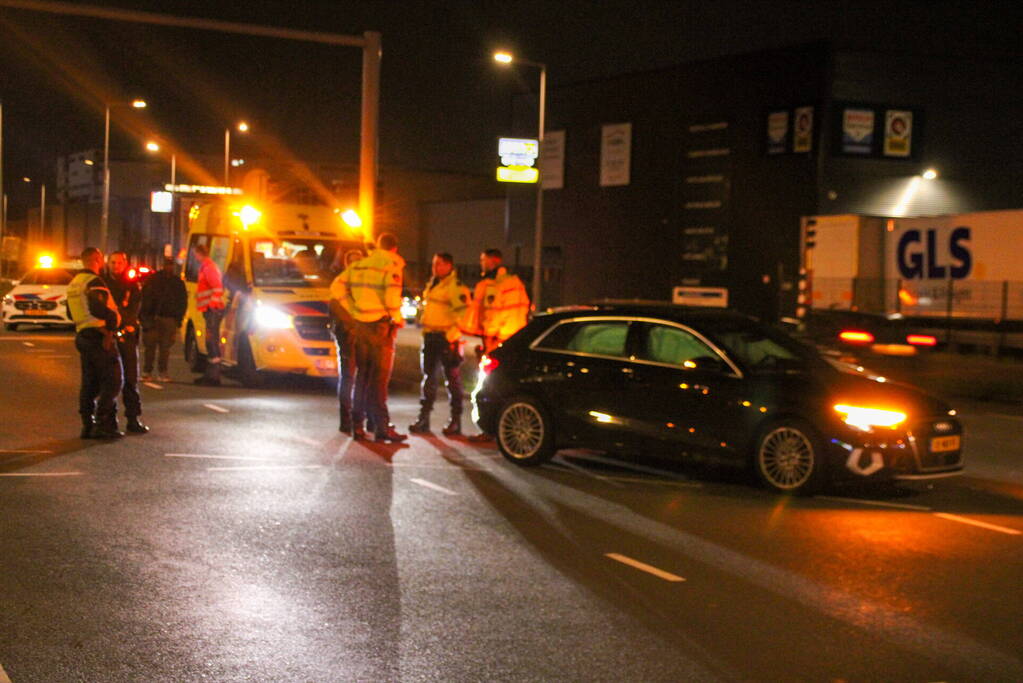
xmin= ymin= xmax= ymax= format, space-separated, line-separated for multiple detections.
xmin=753 ymin=419 xmax=826 ymax=495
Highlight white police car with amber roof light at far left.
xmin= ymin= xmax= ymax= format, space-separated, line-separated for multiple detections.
xmin=2 ymin=256 xmax=82 ymax=331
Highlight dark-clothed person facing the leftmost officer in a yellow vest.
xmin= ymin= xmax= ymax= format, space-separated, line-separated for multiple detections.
xmin=103 ymin=252 xmax=149 ymax=434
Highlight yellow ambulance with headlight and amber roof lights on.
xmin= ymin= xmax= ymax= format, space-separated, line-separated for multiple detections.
xmin=182 ymin=200 xmax=364 ymax=385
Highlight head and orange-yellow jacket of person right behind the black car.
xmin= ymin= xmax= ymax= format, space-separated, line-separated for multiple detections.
xmin=462 ymin=249 xmax=529 ymax=354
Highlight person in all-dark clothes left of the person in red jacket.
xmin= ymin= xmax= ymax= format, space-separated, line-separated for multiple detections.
xmin=138 ymin=259 xmax=188 ymax=381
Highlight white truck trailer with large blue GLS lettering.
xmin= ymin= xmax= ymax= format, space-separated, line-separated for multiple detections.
xmin=798 ymin=210 xmax=1023 ymax=354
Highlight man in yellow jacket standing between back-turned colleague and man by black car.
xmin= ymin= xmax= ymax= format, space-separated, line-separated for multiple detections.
xmin=408 ymin=253 xmax=469 ymax=437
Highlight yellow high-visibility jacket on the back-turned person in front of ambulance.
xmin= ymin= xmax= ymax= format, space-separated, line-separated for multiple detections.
xmin=330 ymin=249 xmax=405 ymax=325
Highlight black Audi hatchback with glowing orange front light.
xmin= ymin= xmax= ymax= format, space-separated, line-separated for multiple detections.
xmin=473 ymin=304 xmax=963 ymax=494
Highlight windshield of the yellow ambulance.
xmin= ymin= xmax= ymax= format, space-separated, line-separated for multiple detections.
xmin=252 ymin=238 xmax=341 ymax=287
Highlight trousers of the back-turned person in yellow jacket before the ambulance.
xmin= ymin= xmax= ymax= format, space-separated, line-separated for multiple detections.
xmin=352 ymin=320 xmax=398 ymax=434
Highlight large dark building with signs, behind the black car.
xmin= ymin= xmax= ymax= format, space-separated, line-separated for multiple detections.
xmin=508 ymin=43 xmax=1023 ymax=317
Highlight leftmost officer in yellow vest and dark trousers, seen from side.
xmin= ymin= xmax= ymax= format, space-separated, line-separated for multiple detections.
xmin=68 ymin=246 xmax=124 ymax=439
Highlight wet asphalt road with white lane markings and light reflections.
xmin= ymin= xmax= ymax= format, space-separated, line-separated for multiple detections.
xmin=0 ymin=330 xmax=1023 ymax=683
